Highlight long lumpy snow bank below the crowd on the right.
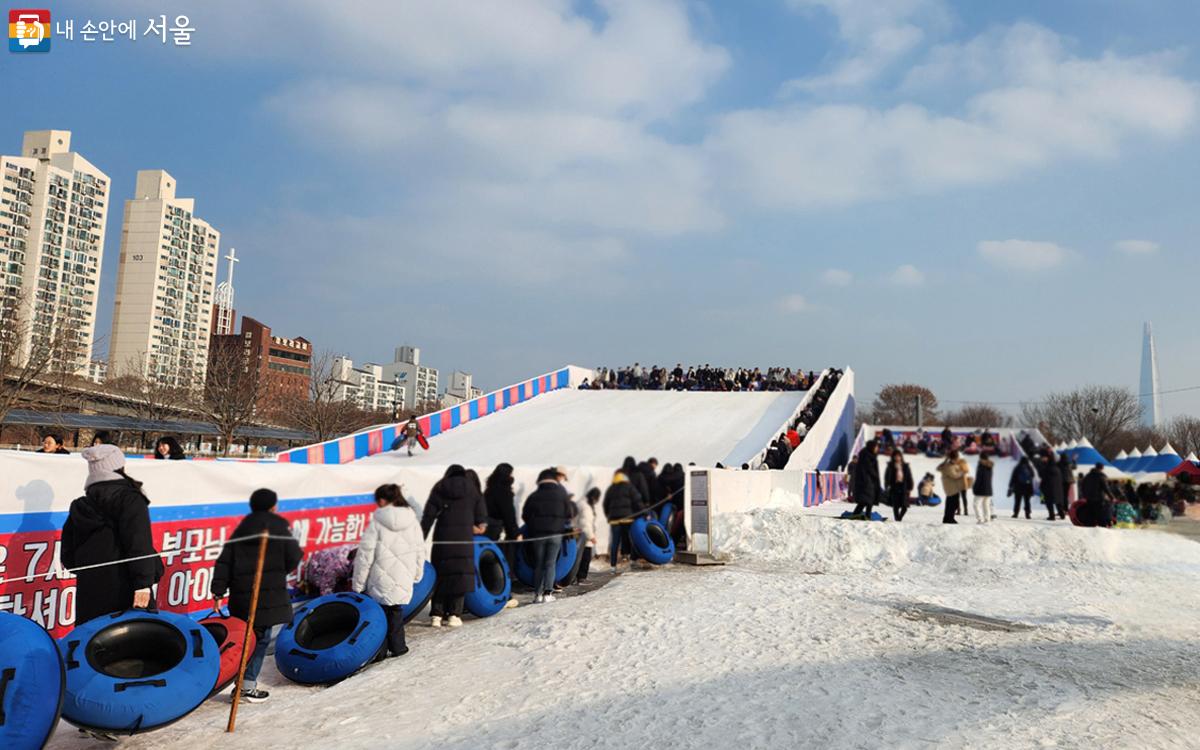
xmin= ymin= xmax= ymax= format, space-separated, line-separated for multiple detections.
xmin=714 ymin=505 xmax=1200 ymax=575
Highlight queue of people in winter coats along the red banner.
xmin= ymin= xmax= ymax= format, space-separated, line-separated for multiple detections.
xmin=56 ymin=443 xmax=686 ymax=702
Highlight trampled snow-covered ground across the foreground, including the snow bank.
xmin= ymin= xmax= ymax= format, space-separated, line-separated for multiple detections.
xmin=50 ymin=505 xmax=1200 ymax=750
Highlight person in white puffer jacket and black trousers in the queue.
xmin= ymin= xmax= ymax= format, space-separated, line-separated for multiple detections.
xmin=353 ymin=485 xmax=425 ymax=656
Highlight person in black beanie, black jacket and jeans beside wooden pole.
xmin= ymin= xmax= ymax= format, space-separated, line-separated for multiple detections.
xmin=210 ymin=490 xmax=302 ymax=703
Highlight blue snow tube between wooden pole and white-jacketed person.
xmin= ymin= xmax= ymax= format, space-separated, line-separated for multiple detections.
xmin=275 ymin=592 xmax=388 ymax=685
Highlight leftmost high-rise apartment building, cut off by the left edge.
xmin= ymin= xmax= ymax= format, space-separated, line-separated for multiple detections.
xmin=0 ymin=131 xmax=109 ymax=374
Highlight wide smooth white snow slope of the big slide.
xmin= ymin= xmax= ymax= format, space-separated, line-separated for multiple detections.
xmin=360 ymin=390 xmax=805 ymax=467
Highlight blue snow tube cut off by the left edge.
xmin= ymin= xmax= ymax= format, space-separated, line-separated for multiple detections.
xmin=0 ymin=612 xmax=66 ymax=750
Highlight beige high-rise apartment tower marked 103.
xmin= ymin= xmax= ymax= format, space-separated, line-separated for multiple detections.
xmin=108 ymin=169 xmax=221 ymax=389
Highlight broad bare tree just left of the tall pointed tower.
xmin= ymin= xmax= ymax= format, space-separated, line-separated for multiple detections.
xmin=1021 ymin=385 xmax=1141 ymax=455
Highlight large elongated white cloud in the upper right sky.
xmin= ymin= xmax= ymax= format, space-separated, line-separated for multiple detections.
xmin=706 ymin=24 xmax=1198 ymax=210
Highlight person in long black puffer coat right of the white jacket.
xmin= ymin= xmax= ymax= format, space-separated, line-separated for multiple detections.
xmin=421 ymin=463 xmax=487 ymax=628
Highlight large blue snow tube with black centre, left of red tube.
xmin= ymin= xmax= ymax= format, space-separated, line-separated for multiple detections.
xmin=59 ymin=610 xmax=221 ymax=734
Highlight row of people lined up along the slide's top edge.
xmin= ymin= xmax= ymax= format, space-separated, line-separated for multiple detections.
xmin=580 ymin=362 xmax=817 ymax=391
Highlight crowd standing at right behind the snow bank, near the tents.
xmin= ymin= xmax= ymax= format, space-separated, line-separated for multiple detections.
xmin=847 ymin=428 xmax=1196 ymax=528
